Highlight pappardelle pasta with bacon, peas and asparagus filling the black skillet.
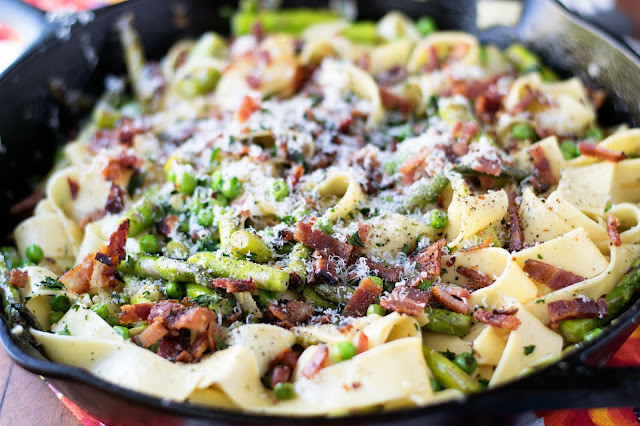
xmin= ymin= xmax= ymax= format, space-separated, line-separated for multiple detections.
xmin=0 ymin=5 xmax=640 ymax=415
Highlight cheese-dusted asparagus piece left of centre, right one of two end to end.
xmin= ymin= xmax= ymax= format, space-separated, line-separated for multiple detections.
xmin=189 ymin=252 xmax=289 ymax=292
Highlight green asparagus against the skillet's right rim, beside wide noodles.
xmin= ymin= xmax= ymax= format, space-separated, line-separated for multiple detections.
xmin=559 ymin=259 xmax=640 ymax=343
